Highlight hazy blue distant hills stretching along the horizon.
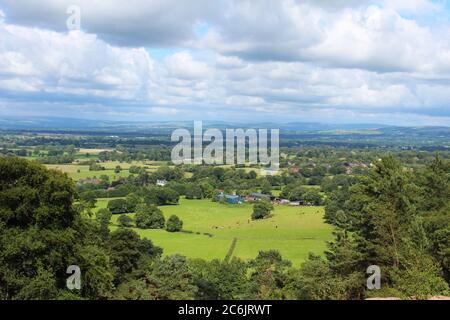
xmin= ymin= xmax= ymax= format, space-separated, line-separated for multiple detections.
xmin=0 ymin=117 xmax=450 ymax=146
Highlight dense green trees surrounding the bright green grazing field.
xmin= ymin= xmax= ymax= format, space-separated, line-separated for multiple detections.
xmin=0 ymin=150 xmax=450 ymax=299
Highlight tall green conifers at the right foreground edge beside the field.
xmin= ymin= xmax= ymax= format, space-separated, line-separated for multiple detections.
xmin=320 ymin=156 xmax=450 ymax=298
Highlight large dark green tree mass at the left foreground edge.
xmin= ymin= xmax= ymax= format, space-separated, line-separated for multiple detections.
xmin=0 ymin=158 xmax=110 ymax=299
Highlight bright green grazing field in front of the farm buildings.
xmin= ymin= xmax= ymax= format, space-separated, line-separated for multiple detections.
xmin=97 ymin=199 xmax=333 ymax=266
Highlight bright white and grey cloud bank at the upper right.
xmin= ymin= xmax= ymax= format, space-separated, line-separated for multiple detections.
xmin=201 ymin=0 xmax=450 ymax=72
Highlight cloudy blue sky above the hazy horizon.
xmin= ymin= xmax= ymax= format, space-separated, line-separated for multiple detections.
xmin=0 ymin=0 xmax=450 ymax=126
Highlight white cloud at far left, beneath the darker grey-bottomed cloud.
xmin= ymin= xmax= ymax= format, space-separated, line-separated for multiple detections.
xmin=0 ymin=23 xmax=153 ymax=99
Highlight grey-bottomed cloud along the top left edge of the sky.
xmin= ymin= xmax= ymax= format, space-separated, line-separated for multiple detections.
xmin=0 ymin=0 xmax=216 ymax=46
